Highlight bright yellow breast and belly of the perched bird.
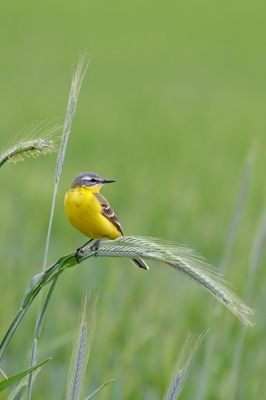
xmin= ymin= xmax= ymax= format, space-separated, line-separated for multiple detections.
xmin=64 ymin=186 xmax=121 ymax=239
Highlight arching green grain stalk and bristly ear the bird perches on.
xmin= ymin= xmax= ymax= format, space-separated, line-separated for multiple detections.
xmin=0 ymin=236 xmax=253 ymax=360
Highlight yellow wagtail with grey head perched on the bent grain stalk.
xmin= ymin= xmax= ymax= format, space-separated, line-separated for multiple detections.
xmin=64 ymin=172 xmax=149 ymax=269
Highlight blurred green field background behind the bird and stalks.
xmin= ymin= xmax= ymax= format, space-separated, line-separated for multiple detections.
xmin=0 ymin=0 xmax=266 ymax=400
